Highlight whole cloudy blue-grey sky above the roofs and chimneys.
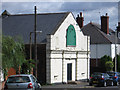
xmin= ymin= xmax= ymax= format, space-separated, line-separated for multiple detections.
xmin=2 ymin=0 xmax=120 ymax=30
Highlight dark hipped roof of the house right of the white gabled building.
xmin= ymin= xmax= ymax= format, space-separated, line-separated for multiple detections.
xmin=81 ymin=22 xmax=120 ymax=44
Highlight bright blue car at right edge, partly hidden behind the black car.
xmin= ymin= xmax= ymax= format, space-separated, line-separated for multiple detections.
xmin=107 ymin=71 xmax=120 ymax=86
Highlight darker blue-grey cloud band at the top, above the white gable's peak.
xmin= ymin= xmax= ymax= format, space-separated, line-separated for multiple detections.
xmin=61 ymin=2 xmax=116 ymax=11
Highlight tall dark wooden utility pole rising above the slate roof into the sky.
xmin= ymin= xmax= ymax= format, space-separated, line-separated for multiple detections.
xmin=34 ymin=6 xmax=37 ymax=78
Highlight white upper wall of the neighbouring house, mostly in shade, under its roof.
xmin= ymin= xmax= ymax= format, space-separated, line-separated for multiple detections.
xmin=90 ymin=44 xmax=120 ymax=59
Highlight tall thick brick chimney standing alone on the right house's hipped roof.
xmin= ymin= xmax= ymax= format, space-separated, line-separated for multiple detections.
xmin=101 ymin=13 xmax=109 ymax=34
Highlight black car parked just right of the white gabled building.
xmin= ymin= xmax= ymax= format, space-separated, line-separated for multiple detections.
xmin=89 ymin=72 xmax=113 ymax=87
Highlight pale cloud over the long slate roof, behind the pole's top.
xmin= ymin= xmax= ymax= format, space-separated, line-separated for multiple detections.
xmin=2 ymin=2 xmax=63 ymax=14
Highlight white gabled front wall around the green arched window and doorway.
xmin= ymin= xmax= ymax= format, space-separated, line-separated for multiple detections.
xmin=46 ymin=13 xmax=90 ymax=83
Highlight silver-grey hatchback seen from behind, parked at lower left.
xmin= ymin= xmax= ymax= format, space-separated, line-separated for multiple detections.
xmin=4 ymin=74 xmax=41 ymax=90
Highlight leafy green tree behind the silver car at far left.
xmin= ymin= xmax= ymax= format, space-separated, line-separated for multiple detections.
xmin=2 ymin=36 xmax=25 ymax=76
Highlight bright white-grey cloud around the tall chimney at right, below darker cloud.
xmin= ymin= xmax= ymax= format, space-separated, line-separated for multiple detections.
xmin=84 ymin=6 xmax=118 ymax=30
